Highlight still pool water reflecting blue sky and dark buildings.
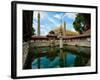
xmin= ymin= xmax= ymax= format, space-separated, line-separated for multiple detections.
xmin=31 ymin=47 xmax=90 ymax=69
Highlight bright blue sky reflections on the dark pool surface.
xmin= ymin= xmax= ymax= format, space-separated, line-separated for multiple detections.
xmin=32 ymin=53 xmax=76 ymax=69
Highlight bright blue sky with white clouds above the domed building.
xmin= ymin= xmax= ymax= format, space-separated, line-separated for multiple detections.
xmin=33 ymin=11 xmax=77 ymax=36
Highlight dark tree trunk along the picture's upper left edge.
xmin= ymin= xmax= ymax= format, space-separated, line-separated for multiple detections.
xmin=23 ymin=10 xmax=33 ymax=42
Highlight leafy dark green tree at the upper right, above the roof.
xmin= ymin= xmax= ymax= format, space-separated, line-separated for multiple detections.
xmin=73 ymin=13 xmax=90 ymax=34
